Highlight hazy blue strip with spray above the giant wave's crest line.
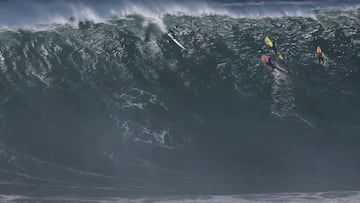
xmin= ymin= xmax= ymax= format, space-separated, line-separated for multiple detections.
xmin=0 ymin=1 xmax=360 ymax=28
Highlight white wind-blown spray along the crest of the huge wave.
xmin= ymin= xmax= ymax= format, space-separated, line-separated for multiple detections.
xmin=0 ymin=1 xmax=360 ymax=31
